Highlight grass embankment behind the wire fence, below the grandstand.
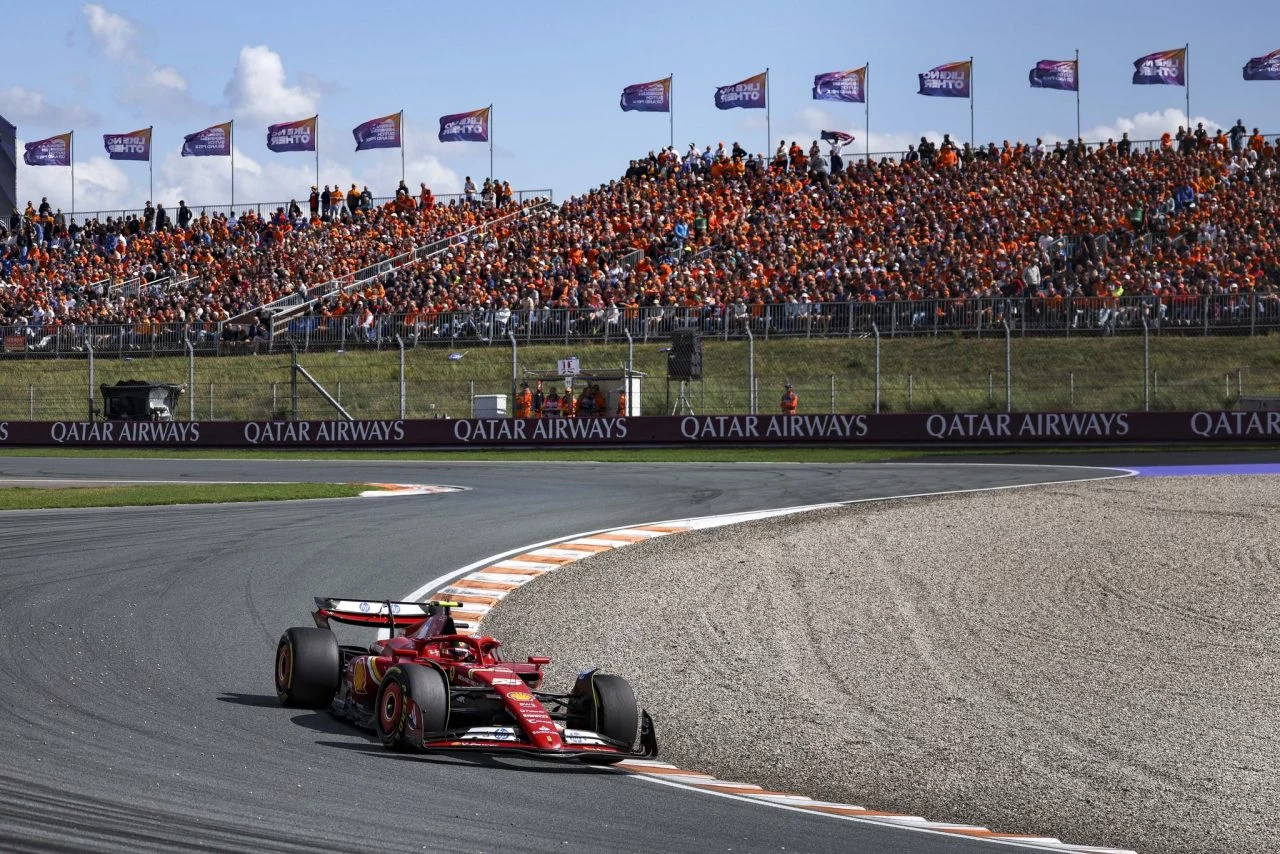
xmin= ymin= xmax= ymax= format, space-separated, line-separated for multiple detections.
xmin=0 ymin=335 xmax=1280 ymax=420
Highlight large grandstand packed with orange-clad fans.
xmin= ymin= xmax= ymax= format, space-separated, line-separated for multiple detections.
xmin=0 ymin=131 xmax=1280 ymax=353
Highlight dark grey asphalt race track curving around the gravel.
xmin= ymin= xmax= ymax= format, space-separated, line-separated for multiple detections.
xmin=0 ymin=457 xmax=1141 ymax=854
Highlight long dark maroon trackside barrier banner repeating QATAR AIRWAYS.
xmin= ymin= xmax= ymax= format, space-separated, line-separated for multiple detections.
xmin=0 ymin=411 xmax=1280 ymax=448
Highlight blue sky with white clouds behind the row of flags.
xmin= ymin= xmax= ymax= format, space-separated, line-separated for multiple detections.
xmin=0 ymin=0 xmax=1280 ymax=210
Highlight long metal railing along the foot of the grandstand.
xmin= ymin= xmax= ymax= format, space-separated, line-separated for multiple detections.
xmin=0 ymin=293 xmax=1280 ymax=357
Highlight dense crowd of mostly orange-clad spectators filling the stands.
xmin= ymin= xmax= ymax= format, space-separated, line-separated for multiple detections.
xmin=0 ymin=122 xmax=1280 ymax=335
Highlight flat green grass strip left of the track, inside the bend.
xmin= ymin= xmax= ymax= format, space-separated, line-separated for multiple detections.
xmin=0 ymin=483 xmax=369 ymax=510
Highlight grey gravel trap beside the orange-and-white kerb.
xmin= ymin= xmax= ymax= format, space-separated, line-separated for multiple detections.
xmin=484 ymin=478 xmax=1280 ymax=854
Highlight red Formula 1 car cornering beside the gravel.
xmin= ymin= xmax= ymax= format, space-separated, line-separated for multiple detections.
xmin=275 ymin=597 xmax=658 ymax=764
